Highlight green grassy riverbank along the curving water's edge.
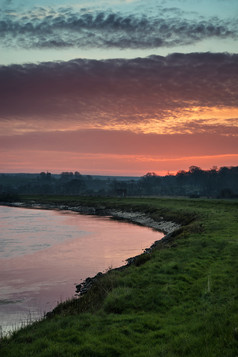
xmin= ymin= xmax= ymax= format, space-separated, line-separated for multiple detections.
xmin=0 ymin=197 xmax=238 ymax=357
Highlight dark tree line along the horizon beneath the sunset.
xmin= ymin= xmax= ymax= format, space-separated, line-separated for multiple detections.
xmin=0 ymin=166 xmax=238 ymax=200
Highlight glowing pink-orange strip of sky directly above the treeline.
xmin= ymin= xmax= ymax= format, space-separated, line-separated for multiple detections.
xmin=1 ymin=150 xmax=238 ymax=176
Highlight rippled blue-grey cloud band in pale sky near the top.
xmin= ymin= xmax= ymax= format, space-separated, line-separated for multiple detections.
xmin=0 ymin=8 xmax=238 ymax=49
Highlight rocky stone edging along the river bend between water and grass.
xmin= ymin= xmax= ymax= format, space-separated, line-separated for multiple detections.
xmin=0 ymin=202 xmax=181 ymax=296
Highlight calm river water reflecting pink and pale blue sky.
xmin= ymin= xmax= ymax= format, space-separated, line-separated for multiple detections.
xmin=0 ymin=206 xmax=163 ymax=333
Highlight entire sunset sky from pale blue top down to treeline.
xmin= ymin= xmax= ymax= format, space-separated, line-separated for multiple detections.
xmin=0 ymin=0 xmax=238 ymax=176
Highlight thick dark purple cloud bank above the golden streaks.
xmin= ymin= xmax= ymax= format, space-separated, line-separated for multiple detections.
xmin=0 ymin=53 xmax=238 ymax=124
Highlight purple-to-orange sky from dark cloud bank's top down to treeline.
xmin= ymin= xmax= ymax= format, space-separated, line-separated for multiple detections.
xmin=0 ymin=53 xmax=238 ymax=176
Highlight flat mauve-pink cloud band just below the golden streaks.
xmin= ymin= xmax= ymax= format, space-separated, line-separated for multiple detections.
xmin=0 ymin=129 xmax=238 ymax=158
